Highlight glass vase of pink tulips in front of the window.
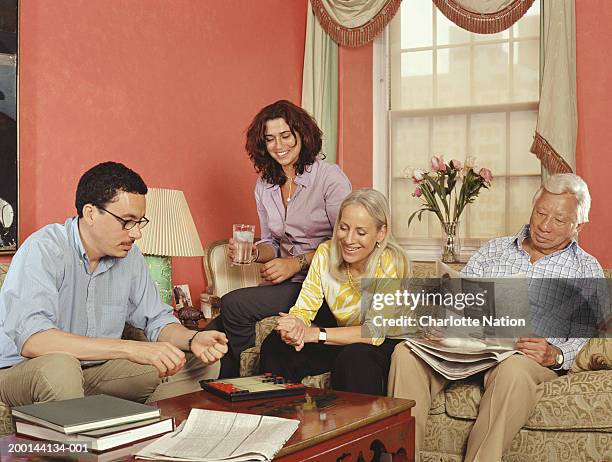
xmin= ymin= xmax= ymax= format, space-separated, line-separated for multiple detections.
xmin=405 ymin=155 xmax=493 ymax=263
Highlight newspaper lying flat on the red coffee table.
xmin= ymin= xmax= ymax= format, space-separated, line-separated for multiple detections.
xmin=136 ymin=409 xmax=300 ymax=462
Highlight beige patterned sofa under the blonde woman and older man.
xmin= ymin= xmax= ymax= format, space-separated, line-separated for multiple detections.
xmin=240 ymin=263 xmax=612 ymax=462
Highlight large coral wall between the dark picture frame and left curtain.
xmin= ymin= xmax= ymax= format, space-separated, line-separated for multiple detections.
xmin=4 ymin=0 xmax=307 ymax=298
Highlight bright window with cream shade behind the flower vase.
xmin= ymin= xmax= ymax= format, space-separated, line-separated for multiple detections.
xmin=374 ymin=0 xmax=541 ymax=259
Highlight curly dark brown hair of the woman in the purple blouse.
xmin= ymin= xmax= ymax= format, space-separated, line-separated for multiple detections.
xmin=245 ymin=100 xmax=323 ymax=186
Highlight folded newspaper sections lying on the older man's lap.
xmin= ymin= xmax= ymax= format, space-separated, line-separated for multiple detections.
xmin=406 ymin=338 xmax=520 ymax=380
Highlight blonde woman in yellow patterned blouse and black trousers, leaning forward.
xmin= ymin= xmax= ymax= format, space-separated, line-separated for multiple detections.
xmin=260 ymin=189 xmax=409 ymax=395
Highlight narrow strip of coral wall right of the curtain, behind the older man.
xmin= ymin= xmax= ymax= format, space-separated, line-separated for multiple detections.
xmin=576 ymin=0 xmax=612 ymax=268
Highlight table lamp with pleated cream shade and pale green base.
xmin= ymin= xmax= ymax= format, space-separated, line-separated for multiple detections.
xmin=138 ymin=188 xmax=204 ymax=305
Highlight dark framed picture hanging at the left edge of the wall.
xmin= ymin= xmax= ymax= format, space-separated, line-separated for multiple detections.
xmin=0 ymin=0 xmax=19 ymax=254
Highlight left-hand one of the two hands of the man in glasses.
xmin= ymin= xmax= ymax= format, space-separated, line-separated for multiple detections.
xmin=126 ymin=341 xmax=185 ymax=377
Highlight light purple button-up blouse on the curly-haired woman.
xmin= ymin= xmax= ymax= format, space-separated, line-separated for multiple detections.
xmin=255 ymin=159 xmax=351 ymax=282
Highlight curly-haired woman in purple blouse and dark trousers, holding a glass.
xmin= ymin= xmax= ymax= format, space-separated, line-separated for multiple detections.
xmin=221 ymin=100 xmax=351 ymax=377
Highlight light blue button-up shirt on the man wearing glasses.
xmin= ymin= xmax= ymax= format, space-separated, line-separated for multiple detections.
xmin=0 ymin=217 xmax=178 ymax=367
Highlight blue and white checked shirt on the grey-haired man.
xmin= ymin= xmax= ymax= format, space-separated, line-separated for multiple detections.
xmin=461 ymin=225 xmax=607 ymax=369
